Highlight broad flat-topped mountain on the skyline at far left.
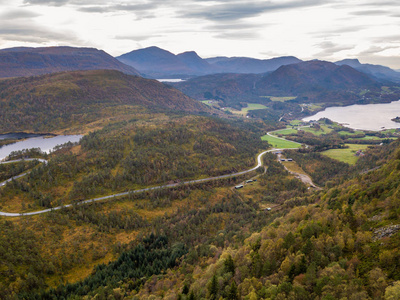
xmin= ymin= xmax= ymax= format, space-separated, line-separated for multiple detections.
xmin=0 ymin=47 xmax=139 ymax=78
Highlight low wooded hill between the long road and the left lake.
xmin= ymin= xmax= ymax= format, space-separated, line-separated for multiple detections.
xmin=0 ymin=116 xmax=267 ymax=210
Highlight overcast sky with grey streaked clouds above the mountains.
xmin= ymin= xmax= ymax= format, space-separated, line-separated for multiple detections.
xmin=0 ymin=0 xmax=400 ymax=69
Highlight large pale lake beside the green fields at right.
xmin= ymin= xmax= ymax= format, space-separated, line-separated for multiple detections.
xmin=303 ymin=100 xmax=400 ymax=131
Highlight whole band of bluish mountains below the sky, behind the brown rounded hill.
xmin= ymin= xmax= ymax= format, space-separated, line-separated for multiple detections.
xmin=0 ymin=47 xmax=400 ymax=115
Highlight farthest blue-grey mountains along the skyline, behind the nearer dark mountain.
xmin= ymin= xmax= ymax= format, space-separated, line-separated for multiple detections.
xmin=0 ymin=46 xmax=400 ymax=83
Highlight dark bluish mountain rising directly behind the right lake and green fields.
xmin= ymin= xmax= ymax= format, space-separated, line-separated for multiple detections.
xmin=172 ymin=61 xmax=394 ymax=106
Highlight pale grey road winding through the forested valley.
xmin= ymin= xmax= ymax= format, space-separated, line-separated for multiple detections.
xmin=0 ymin=132 xmax=304 ymax=217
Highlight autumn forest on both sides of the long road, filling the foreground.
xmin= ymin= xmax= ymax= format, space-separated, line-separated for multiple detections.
xmin=0 ymin=117 xmax=400 ymax=299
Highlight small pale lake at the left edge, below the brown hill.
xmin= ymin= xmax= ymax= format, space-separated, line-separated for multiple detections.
xmin=0 ymin=135 xmax=83 ymax=160
